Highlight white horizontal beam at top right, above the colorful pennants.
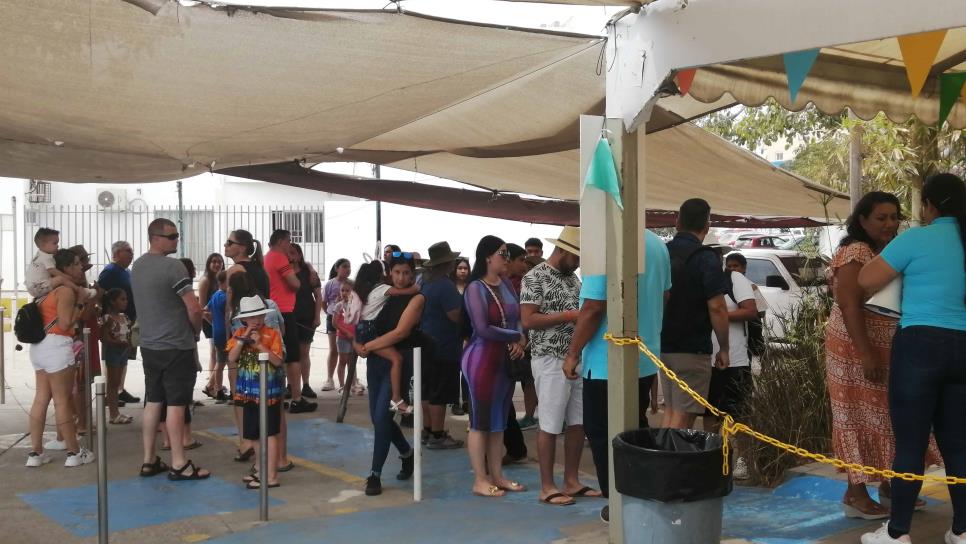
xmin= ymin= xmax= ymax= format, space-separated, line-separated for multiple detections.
xmin=607 ymin=0 xmax=966 ymax=130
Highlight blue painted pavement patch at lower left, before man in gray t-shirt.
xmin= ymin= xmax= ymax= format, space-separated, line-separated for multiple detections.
xmin=17 ymin=474 xmax=284 ymax=537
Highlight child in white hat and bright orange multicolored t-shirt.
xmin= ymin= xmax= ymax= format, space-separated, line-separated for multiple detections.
xmin=227 ymin=296 xmax=285 ymax=489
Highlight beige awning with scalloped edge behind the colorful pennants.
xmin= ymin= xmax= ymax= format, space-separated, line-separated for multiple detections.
xmin=690 ymin=28 xmax=966 ymax=128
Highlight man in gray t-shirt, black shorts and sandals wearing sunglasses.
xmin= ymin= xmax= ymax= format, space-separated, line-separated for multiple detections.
xmin=131 ymin=218 xmax=211 ymax=480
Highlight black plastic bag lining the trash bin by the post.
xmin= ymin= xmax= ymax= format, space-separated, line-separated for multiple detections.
xmin=614 ymin=429 xmax=733 ymax=502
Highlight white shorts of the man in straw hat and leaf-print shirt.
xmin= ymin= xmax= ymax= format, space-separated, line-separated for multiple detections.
xmin=530 ymin=356 xmax=584 ymax=434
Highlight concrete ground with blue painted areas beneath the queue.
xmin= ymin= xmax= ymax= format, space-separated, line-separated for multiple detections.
xmin=0 ymin=334 xmax=951 ymax=544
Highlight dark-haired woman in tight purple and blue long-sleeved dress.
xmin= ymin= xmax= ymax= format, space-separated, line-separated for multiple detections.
xmin=462 ymin=236 xmax=526 ymax=497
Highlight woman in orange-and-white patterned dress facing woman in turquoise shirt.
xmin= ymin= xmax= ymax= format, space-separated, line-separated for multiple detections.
xmin=825 ymin=191 xmax=939 ymax=519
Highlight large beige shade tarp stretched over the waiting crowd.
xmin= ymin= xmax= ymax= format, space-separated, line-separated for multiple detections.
xmin=0 ymin=0 xmax=845 ymax=217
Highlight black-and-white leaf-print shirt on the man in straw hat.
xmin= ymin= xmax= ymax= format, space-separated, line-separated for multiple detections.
xmin=520 ymin=262 xmax=580 ymax=359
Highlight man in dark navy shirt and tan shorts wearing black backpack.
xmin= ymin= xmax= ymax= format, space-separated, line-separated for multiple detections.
xmin=660 ymin=198 xmax=731 ymax=429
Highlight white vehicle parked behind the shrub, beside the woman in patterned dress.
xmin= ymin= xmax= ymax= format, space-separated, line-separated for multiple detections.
xmin=740 ymin=248 xmax=828 ymax=342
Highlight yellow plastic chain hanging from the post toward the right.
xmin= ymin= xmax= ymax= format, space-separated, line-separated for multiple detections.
xmin=604 ymin=333 xmax=966 ymax=485
